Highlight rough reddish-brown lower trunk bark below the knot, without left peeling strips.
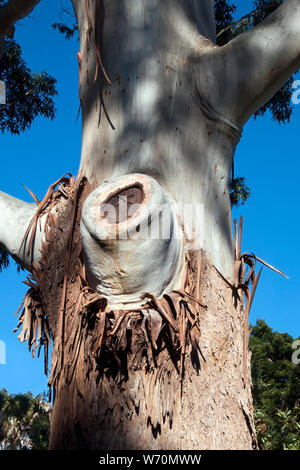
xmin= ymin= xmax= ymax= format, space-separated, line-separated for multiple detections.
xmin=51 ymin=253 xmax=256 ymax=449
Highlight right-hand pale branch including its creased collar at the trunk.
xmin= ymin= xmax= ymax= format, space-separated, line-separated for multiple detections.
xmin=192 ymin=0 xmax=300 ymax=130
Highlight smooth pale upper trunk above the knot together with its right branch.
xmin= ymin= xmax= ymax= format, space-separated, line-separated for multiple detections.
xmin=74 ymin=0 xmax=300 ymax=277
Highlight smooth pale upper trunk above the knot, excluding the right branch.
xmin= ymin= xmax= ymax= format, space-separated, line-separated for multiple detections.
xmin=76 ymin=0 xmax=239 ymax=276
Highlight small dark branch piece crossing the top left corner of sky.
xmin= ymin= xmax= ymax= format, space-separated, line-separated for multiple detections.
xmin=0 ymin=0 xmax=40 ymax=35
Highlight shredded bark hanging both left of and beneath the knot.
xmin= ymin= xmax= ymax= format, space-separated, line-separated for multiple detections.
xmin=14 ymin=175 xmax=210 ymax=404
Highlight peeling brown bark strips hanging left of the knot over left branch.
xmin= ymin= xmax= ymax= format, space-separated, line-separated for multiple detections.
xmin=15 ymin=175 xmax=89 ymax=374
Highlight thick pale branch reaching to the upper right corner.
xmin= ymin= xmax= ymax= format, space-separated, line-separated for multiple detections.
xmin=217 ymin=0 xmax=300 ymax=126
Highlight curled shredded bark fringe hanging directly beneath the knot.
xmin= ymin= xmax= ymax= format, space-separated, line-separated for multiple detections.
xmin=49 ymin=252 xmax=206 ymax=402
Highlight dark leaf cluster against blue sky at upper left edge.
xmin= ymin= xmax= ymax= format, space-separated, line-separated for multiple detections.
xmin=0 ymin=38 xmax=57 ymax=134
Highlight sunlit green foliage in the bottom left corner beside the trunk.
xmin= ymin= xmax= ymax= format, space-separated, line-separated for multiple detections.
xmin=0 ymin=389 xmax=50 ymax=450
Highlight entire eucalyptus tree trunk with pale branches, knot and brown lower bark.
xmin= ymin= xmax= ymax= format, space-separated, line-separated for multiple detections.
xmin=0 ymin=0 xmax=300 ymax=449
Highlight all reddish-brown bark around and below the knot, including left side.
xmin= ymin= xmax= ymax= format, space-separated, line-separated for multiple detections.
xmin=14 ymin=175 xmax=256 ymax=449
